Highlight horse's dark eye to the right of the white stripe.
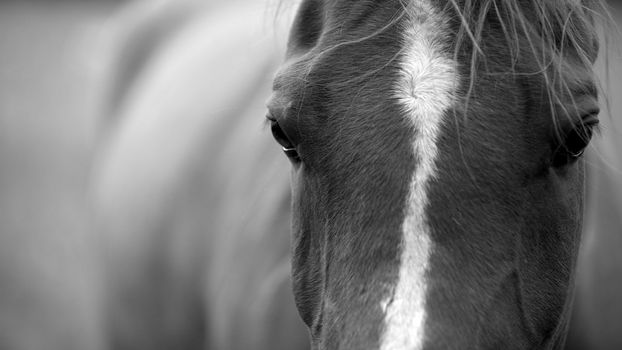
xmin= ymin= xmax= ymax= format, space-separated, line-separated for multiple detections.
xmin=553 ymin=115 xmax=598 ymax=167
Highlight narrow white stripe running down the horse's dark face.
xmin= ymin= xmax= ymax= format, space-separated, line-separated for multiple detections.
xmin=380 ymin=0 xmax=457 ymax=350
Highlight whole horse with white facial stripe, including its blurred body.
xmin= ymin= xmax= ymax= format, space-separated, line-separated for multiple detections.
xmin=93 ymin=0 xmax=620 ymax=349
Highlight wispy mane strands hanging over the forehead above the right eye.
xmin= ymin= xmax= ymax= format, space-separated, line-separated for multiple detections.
xmin=446 ymin=0 xmax=613 ymax=121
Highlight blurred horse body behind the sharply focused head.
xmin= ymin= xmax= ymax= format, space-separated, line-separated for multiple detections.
xmin=93 ymin=0 xmax=622 ymax=350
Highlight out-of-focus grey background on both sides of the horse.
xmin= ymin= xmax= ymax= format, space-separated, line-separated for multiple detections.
xmin=0 ymin=0 xmax=622 ymax=350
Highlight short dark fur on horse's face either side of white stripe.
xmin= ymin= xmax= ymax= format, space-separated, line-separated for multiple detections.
xmin=269 ymin=0 xmax=602 ymax=349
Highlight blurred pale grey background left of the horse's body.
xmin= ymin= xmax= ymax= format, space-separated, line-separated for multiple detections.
xmin=0 ymin=1 xmax=113 ymax=350
